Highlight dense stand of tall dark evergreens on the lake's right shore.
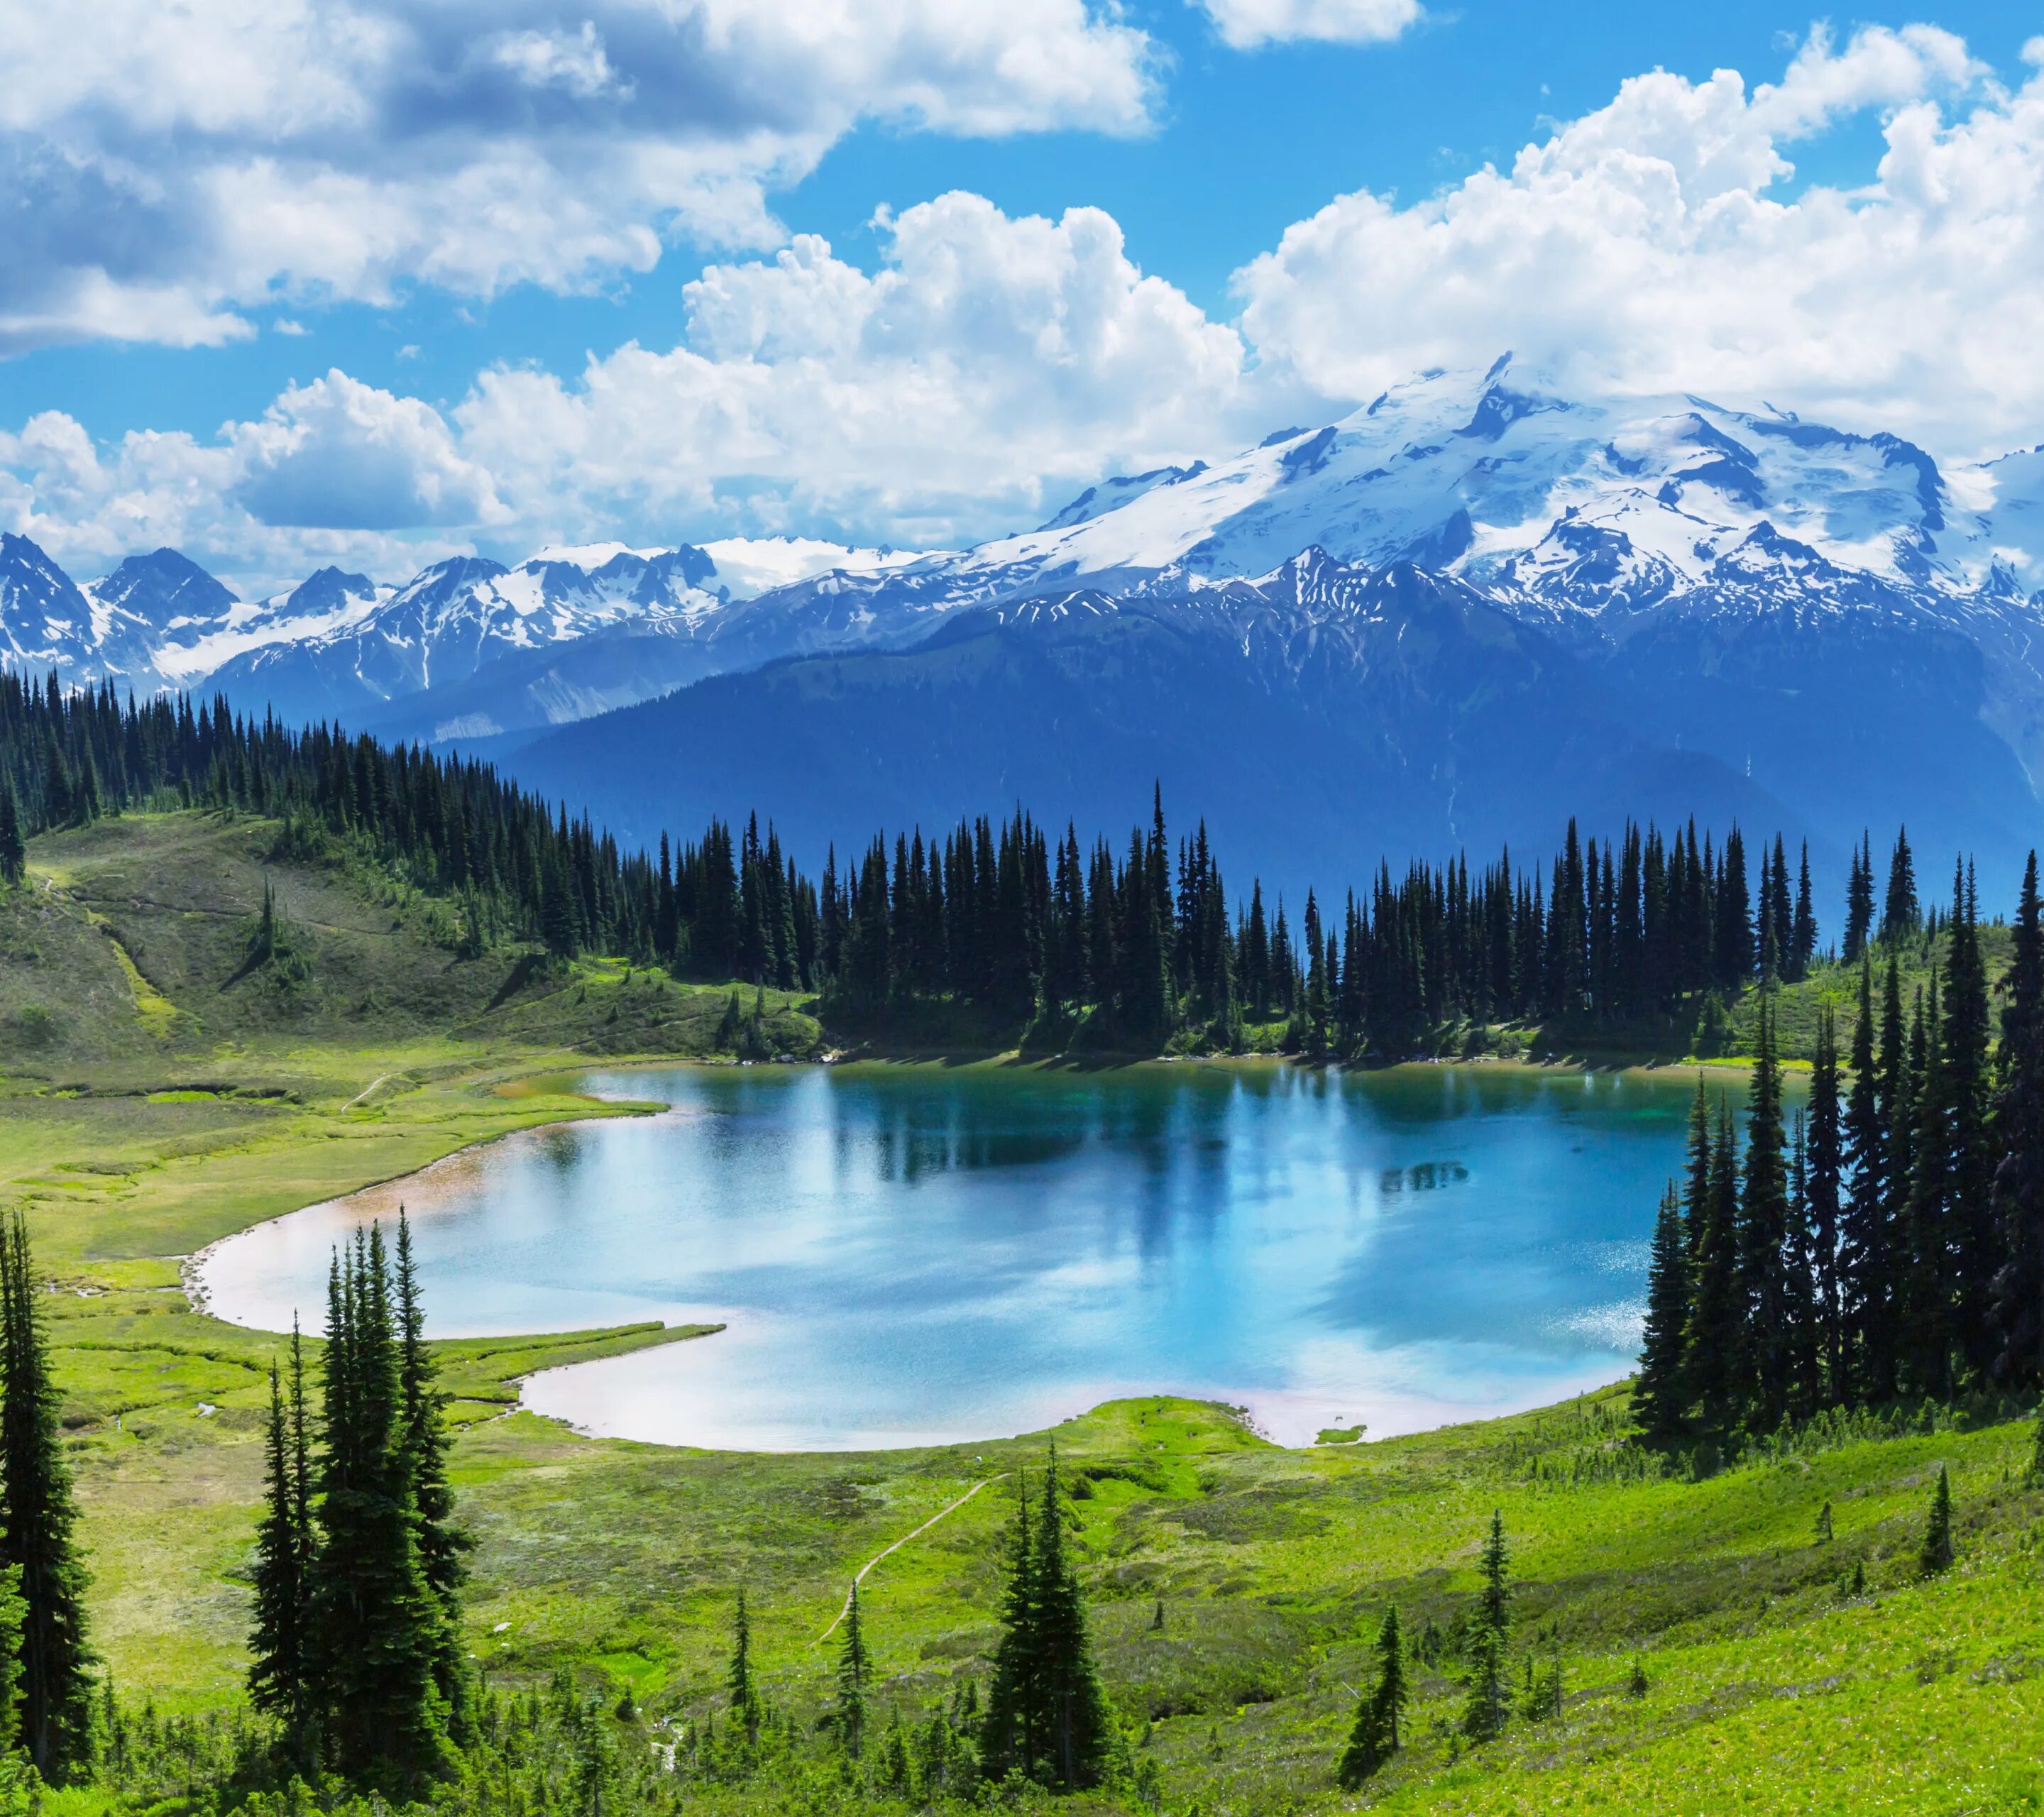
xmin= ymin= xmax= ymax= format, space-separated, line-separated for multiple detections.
xmin=1633 ymin=855 xmax=2044 ymax=1443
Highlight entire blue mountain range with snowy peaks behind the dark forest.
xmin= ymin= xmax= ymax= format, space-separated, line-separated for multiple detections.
xmin=11 ymin=358 xmax=2044 ymax=889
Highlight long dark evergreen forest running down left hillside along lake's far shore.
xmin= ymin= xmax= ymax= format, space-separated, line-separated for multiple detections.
xmin=0 ymin=674 xmax=1962 ymax=1059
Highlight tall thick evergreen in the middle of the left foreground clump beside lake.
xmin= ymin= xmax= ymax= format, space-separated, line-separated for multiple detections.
xmin=313 ymin=1226 xmax=450 ymax=1791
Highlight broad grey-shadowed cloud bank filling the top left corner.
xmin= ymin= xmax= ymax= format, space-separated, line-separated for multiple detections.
xmin=0 ymin=0 xmax=1155 ymax=353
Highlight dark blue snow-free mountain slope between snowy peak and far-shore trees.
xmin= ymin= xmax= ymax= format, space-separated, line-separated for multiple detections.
xmin=509 ymin=558 xmax=1793 ymax=899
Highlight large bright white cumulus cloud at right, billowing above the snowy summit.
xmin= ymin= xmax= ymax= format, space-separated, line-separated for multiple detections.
xmin=1236 ymin=26 xmax=2044 ymax=454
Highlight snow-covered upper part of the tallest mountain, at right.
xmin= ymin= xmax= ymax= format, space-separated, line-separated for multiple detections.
xmin=967 ymin=358 xmax=1994 ymax=605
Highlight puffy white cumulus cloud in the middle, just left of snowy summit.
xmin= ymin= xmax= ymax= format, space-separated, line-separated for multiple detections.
xmin=456 ymin=194 xmax=1249 ymax=542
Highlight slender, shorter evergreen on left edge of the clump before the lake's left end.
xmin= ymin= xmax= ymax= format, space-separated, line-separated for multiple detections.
xmin=247 ymin=1320 xmax=317 ymax=1738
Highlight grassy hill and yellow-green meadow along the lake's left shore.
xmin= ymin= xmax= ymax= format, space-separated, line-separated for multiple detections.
xmin=0 ymin=816 xmax=815 ymax=1701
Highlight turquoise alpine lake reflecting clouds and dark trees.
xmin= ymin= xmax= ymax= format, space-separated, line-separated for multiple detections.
xmin=202 ymin=1065 xmax=1735 ymax=1449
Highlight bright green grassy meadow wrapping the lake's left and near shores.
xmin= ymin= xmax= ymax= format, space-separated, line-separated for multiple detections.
xmin=0 ymin=818 xmax=2044 ymax=1813
